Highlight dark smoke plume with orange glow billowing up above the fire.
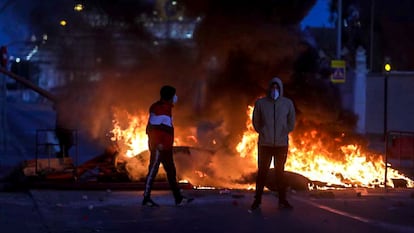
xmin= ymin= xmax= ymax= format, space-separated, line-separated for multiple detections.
xmin=6 ymin=0 xmax=360 ymax=185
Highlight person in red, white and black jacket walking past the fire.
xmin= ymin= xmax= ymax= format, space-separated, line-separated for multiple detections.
xmin=142 ymin=85 xmax=193 ymax=207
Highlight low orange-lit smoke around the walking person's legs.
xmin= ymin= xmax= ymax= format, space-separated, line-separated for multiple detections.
xmin=120 ymin=147 xmax=256 ymax=188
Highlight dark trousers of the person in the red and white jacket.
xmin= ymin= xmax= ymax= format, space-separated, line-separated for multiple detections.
xmin=144 ymin=150 xmax=181 ymax=200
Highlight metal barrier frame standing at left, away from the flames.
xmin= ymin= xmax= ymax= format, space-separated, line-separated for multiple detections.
xmin=35 ymin=129 xmax=79 ymax=174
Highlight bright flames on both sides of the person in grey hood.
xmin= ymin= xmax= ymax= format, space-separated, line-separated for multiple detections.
xmin=237 ymin=106 xmax=414 ymax=187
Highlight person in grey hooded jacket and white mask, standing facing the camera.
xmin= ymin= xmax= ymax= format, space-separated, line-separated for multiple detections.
xmin=250 ymin=77 xmax=296 ymax=211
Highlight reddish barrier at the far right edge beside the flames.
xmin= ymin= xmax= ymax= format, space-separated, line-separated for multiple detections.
xmin=384 ymin=131 xmax=414 ymax=186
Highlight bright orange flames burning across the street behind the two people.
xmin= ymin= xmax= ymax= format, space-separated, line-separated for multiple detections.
xmin=111 ymin=106 xmax=414 ymax=188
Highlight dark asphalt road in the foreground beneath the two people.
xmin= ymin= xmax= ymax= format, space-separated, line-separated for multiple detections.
xmin=0 ymin=189 xmax=414 ymax=233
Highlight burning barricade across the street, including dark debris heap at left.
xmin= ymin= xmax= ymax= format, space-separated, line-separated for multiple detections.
xmin=4 ymin=106 xmax=414 ymax=190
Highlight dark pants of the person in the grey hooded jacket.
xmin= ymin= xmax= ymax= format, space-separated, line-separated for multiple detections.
xmin=255 ymin=146 xmax=288 ymax=203
